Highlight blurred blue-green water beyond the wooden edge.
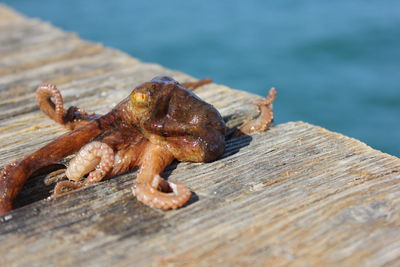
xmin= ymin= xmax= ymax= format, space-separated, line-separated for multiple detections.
xmin=3 ymin=0 xmax=400 ymax=156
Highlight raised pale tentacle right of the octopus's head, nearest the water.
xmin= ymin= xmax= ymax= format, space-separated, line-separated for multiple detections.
xmin=235 ymin=88 xmax=276 ymax=136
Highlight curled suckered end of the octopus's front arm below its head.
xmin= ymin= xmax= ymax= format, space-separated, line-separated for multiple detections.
xmin=132 ymin=174 xmax=192 ymax=210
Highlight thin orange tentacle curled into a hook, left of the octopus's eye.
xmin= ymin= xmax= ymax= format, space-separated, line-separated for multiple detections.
xmin=36 ymin=83 xmax=100 ymax=130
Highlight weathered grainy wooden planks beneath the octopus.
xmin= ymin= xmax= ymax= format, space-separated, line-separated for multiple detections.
xmin=0 ymin=6 xmax=400 ymax=266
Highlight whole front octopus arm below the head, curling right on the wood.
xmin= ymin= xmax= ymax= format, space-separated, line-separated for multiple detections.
xmin=132 ymin=142 xmax=191 ymax=210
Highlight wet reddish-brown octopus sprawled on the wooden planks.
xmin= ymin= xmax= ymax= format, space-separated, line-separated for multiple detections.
xmin=0 ymin=77 xmax=276 ymax=214
